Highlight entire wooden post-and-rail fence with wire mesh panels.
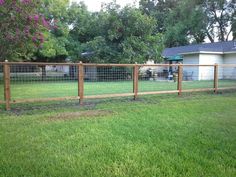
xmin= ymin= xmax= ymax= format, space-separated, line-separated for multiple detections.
xmin=0 ymin=62 xmax=236 ymax=110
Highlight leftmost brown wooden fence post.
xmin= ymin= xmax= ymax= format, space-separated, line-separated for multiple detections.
xmin=3 ymin=60 xmax=11 ymax=111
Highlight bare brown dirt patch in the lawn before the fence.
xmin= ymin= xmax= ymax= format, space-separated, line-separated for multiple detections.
xmin=48 ymin=110 xmax=113 ymax=121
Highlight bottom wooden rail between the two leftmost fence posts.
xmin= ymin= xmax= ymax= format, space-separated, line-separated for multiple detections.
xmin=11 ymin=96 xmax=79 ymax=104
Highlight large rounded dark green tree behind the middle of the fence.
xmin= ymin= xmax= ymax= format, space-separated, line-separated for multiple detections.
xmin=68 ymin=2 xmax=163 ymax=63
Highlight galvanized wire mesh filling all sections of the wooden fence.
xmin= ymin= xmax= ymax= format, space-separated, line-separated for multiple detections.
xmin=0 ymin=63 xmax=236 ymax=108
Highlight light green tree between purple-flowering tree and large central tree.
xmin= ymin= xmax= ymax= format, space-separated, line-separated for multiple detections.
xmin=34 ymin=0 xmax=69 ymax=62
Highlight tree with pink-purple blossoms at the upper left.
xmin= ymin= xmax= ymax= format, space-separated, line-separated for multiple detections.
xmin=0 ymin=0 xmax=50 ymax=61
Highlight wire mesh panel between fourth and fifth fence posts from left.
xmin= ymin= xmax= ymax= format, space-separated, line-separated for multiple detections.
xmin=182 ymin=65 xmax=214 ymax=90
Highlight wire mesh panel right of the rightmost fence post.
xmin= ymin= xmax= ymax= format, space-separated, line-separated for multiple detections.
xmin=218 ymin=65 xmax=236 ymax=88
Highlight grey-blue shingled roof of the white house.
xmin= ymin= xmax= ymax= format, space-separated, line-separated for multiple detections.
xmin=162 ymin=41 xmax=236 ymax=58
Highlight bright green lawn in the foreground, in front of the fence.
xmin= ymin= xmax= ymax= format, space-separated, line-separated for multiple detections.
xmin=0 ymin=93 xmax=236 ymax=177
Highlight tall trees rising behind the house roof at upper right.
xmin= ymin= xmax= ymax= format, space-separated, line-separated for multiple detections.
xmin=140 ymin=0 xmax=236 ymax=47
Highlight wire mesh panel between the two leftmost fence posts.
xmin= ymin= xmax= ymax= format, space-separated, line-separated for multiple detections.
xmin=10 ymin=64 xmax=78 ymax=100
